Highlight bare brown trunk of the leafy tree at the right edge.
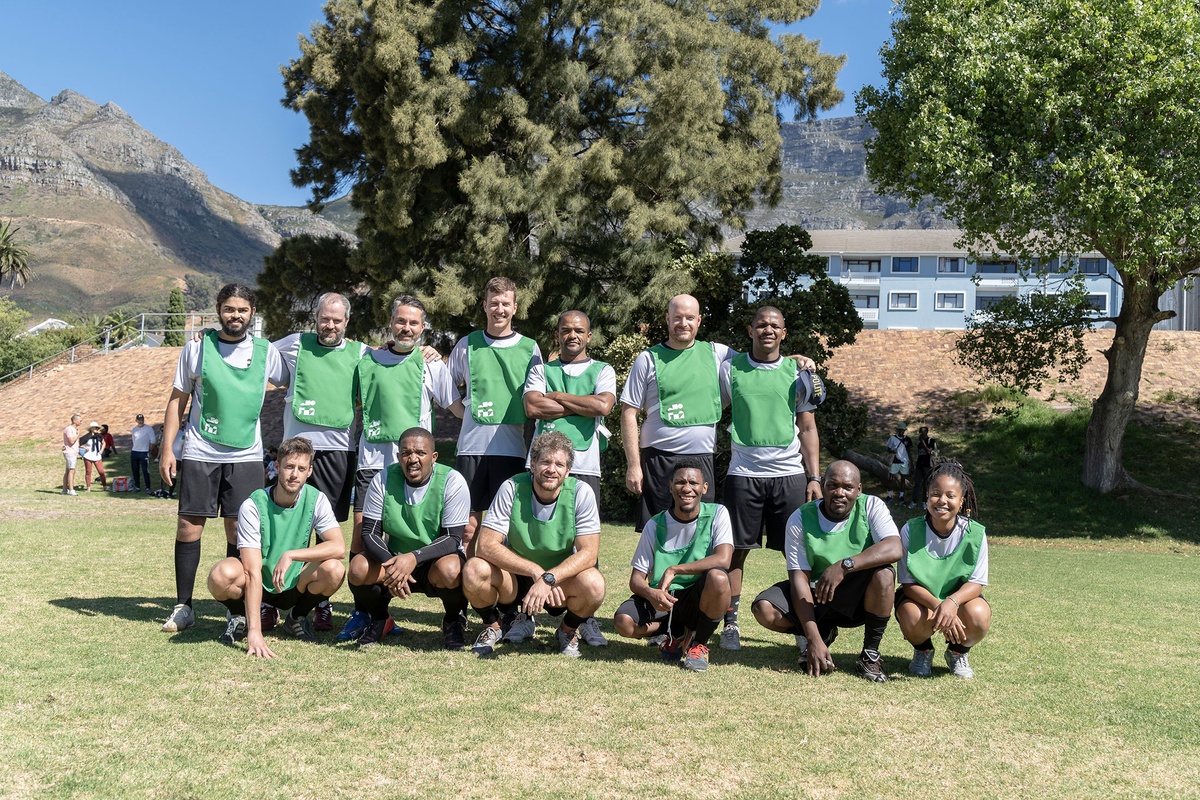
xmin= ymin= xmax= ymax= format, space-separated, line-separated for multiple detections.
xmin=1084 ymin=280 xmax=1172 ymax=493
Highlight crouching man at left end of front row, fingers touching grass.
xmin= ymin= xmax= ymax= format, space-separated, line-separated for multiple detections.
xmin=209 ymin=437 xmax=346 ymax=658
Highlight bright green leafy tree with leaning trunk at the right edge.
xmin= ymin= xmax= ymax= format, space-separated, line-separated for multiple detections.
xmin=858 ymin=0 xmax=1200 ymax=492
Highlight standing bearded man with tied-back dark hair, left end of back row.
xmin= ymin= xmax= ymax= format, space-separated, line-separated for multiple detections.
xmin=158 ymin=283 xmax=289 ymax=633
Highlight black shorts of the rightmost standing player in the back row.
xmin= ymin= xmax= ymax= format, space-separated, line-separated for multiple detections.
xmin=721 ymin=473 xmax=808 ymax=551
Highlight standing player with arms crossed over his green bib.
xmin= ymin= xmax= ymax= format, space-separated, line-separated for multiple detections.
xmin=524 ymin=311 xmax=617 ymax=646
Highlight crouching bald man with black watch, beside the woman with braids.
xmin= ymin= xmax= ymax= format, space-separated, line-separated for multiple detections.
xmin=754 ymin=461 xmax=904 ymax=684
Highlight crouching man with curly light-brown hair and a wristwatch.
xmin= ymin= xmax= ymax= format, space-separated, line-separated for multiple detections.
xmin=462 ymin=431 xmax=605 ymax=658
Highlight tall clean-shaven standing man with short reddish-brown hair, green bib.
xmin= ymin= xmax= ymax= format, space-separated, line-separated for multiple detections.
xmin=450 ymin=277 xmax=541 ymax=555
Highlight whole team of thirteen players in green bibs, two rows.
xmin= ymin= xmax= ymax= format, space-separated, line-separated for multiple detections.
xmin=160 ymin=277 xmax=990 ymax=681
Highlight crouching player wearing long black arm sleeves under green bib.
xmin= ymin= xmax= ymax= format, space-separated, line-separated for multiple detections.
xmin=350 ymin=428 xmax=470 ymax=650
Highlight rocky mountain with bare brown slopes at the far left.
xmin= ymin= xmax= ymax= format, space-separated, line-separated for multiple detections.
xmin=0 ymin=73 xmax=350 ymax=315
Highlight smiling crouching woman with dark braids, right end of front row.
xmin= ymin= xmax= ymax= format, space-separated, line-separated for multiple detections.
xmin=896 ymin=462 xmax=991 ymax=680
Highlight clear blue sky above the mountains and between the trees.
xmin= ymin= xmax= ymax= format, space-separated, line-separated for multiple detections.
xmin=0 ymin=0 xmax=892 ymax=205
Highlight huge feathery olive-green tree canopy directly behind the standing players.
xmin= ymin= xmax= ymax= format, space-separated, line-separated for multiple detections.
xmin=283 ymin=0 xmax=842 ymax=340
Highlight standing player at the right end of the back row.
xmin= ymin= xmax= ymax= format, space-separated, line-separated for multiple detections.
xmin=721 ymin=306 xmax=826 ymax=650
